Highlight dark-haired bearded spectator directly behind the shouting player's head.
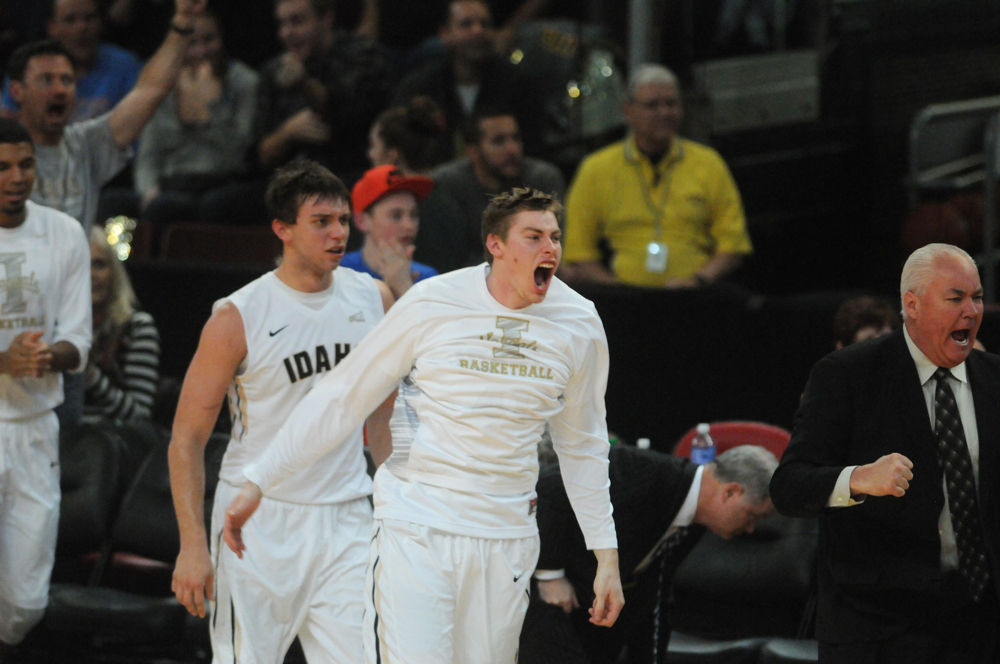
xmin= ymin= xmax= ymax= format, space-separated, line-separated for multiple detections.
xmin=432 ymin=107 xmax=566 ymax=267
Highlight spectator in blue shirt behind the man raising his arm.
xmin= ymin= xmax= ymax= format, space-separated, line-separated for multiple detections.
xmin=3 ymin=0 xmax=142 ymax=122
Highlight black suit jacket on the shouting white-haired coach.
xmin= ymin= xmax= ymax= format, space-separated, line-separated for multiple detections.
xmin=771 ymin=331 xmax=1000 ymax=643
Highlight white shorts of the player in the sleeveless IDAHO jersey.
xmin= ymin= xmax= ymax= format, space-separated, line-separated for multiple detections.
xmin=209 ymin=482 xmax=372 ymax=664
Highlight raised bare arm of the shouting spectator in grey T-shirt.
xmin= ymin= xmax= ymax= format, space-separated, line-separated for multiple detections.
xmin=109 ymin=0 xmax=205 ymax=148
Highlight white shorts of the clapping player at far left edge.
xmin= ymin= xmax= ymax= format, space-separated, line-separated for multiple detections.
xmin=0 ymin=412 xmax=59 ymax=644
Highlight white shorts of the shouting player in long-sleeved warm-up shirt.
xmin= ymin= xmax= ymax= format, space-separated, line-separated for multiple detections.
xmin=364 ymin=519 xmax=538 ymax=664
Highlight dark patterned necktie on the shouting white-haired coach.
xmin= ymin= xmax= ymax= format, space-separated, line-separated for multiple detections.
xmin=934 ymin=367 xmax=990 ymax=601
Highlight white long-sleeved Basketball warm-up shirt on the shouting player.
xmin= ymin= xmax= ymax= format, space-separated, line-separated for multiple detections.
xmin=244 ymin=263 xmax=617 ymax=548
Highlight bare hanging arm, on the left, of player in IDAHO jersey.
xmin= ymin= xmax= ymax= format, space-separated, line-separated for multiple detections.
xmin=168 ymin=303 xmax=247 ymax=617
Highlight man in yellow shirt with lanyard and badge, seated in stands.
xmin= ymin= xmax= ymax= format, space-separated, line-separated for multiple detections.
xmin=562 ymin=64 xmax=753 ymax=288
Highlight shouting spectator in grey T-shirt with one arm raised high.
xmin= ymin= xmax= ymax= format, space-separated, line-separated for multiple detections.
xmin=8 ymin=0 xmax=205 ymax=231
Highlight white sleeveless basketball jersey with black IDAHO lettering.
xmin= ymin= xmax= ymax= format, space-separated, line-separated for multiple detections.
xmin=215 ymin=267 xmax=383 ymax=504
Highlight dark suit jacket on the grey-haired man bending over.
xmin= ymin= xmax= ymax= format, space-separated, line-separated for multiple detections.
xmin=537 ymin=446 xmax=704 ymax=662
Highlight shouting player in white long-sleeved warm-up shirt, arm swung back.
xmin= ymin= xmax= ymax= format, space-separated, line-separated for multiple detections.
xmin=225 ymin=189 xmax=623 ymax=664
